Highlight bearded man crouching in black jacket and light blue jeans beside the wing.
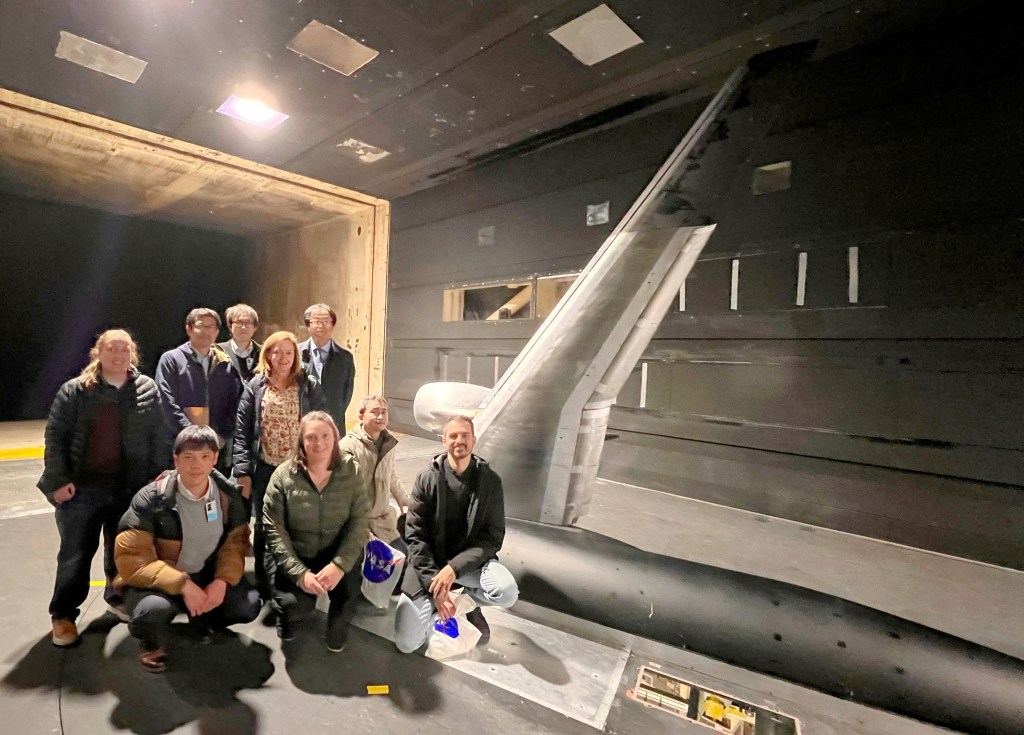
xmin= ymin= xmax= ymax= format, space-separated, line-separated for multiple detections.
xmin=394 ymin=416 xmax=519 ymax=653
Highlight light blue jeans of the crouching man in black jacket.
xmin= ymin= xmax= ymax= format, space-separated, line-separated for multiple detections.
xmin=394 ymin=561 xmax=519 ymax=653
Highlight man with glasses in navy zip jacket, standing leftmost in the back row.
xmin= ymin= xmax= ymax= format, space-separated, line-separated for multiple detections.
xmin=157 ymin=308 xmax=242 ymax=477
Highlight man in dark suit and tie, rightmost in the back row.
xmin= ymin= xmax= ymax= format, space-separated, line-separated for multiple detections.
xmin=299 ymin=304 xmax=355 ymax=433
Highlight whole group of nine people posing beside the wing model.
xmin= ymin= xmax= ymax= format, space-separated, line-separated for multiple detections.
xmin=38 ymin=304 xmax=518 ymax=673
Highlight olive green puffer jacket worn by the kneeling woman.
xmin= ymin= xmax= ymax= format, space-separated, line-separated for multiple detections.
xmin=263 ymin=455 xmax=370 ymax=585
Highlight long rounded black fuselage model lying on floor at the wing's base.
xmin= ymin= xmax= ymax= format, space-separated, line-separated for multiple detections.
xmin=502 ymin=520 xmax=1024 ymax=735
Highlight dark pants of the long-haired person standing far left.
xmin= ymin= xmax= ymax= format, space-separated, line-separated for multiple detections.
xmin=50 ymin=486 xmax=131 ymax=620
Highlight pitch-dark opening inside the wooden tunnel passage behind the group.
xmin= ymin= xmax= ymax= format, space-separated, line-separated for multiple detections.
xmin=0 ymin=193 xmax=249 ymax=421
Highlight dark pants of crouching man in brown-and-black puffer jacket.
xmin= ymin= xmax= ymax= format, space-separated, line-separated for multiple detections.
xmin=125 ymin=572 xmax=261 ymax=651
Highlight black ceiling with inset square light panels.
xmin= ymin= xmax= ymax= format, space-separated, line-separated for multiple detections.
xmin=0 ymin=0 xmax=970 ymax=199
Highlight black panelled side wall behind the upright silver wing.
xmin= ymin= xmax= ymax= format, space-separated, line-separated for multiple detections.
xmin=385 ymin=3 xmax=1024 ymax=566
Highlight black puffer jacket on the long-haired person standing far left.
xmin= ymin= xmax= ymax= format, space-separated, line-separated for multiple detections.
xmin=36 ymin=373 xmax=171 ymax=494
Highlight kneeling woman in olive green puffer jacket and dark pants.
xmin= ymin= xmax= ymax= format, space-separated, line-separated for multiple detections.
xmin=263 ymin=410 xmax=369 ymax=652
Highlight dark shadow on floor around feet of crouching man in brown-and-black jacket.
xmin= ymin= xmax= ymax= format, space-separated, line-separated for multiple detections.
xmin=0 ymin=615 xmax=273 ymax=735
